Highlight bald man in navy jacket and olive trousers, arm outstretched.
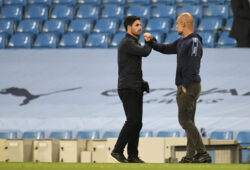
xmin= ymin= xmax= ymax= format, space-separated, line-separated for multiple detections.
xmin=144 ymin=13 xmax=211 ymax=163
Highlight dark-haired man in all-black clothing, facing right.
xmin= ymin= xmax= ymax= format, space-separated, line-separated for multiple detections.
xmin=111 ymin=16 xmax=152 ymax=163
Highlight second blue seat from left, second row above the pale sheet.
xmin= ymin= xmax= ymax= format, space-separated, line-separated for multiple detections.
xmin=16 ymin=19 xmax=40 ymax=34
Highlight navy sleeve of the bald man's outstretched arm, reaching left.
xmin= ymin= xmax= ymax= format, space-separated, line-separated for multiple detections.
xmin=149 ymin=38 xmax=178 ymax=54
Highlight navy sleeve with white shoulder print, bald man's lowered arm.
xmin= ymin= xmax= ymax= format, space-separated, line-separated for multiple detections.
xmin=182 ymin=38 xmax=202 ymax=89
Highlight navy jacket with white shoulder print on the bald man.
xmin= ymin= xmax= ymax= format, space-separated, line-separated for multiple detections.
xmin=150 ymin=33 xmax=203 ymax=89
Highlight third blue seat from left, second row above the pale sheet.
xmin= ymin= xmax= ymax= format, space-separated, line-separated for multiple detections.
xmin=42 ymin=19 xmax=65 ymax=33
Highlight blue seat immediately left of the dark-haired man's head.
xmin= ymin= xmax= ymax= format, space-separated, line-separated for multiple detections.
xmin=93 ymin=18 xmax=119 ymax=33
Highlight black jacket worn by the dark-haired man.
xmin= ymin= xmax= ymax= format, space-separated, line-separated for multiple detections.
xmin=118 ymin=34 xmax=152 ymax=89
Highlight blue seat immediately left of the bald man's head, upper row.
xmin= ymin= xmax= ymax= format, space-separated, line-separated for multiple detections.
xmin=151 ymin=5 xmax=176 ymax=19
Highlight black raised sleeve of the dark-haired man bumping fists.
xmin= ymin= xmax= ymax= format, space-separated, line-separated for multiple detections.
xmin=127 ymin=38 xmax=152 ymax=57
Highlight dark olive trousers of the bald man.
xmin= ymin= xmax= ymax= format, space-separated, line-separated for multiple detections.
xmin=176 ymin=83 xmax=206 ymax=158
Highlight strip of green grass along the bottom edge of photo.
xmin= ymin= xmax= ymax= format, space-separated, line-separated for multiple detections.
xmin=0 ymin=162 xmax=250 ymax=170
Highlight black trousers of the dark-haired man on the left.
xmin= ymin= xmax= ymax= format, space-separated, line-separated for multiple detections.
xmin=114 ymin=89 xmax=143 ymax=157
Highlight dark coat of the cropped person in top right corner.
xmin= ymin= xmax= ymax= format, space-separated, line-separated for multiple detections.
xmin=229 ymin=0 xmax=250 ymax=39
